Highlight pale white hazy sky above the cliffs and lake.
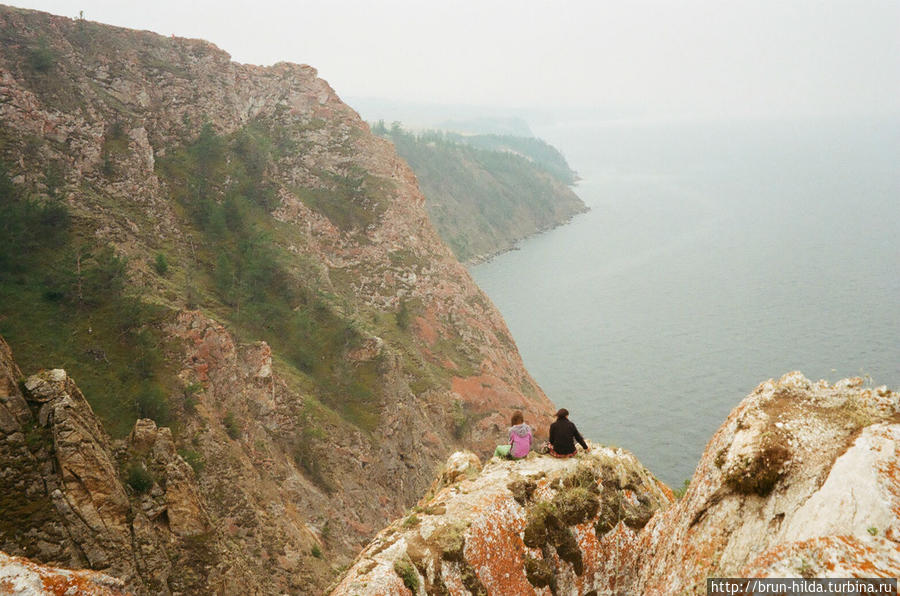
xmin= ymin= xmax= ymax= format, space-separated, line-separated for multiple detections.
xmin=12 ymin=0 xmax=900 ymax=117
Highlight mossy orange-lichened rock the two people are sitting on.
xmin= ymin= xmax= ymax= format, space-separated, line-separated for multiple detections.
xmin=332 ymin=446 xmax=672 ymax=596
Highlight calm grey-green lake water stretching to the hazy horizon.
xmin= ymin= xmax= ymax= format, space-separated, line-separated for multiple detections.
xmin=471 ymin=115 xmax=900 ymax=486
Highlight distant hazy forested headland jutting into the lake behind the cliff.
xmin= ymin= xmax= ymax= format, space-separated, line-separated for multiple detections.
xmin=372 ymin=121 xmax=586 ymax=261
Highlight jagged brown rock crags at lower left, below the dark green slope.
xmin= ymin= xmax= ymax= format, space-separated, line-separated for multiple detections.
xmin=0 ymin=339 xmax=298 ymax=594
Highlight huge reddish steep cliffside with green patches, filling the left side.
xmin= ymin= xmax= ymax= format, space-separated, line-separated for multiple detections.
xmin=0 ymin=7 xmax=551 ymax=593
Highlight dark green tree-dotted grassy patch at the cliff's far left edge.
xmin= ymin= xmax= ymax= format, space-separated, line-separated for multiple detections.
xmin=0 ymin=164 xmax=174 ymax=436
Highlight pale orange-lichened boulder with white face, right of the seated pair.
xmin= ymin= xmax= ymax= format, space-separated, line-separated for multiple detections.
xmin=636 ymin=372 xmax=900 ymax=594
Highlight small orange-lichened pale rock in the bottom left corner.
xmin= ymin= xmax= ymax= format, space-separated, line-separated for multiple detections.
xmin=0 ymin=552 xmax=126 ymax=596
